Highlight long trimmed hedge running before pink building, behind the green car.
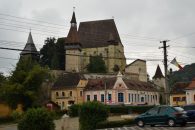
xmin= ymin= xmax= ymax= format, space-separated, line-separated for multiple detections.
xmin=109 ymin=106 xmax=154 ymax=114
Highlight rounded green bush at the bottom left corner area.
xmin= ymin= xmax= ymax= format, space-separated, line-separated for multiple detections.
xmin=18 ymin=108 xmax=55 ymax=130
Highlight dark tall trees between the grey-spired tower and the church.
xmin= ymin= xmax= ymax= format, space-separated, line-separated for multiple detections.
xmin=40 ymin=38 xmax=65 ymax=70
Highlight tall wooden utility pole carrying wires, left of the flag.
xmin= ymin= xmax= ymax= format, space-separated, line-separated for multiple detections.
xmin=159 ymin=40 xmax=170 ymax=105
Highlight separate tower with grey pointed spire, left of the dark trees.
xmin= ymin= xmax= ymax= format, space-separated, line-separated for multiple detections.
xmin=20 ymin=32 xmax=39 ymax=61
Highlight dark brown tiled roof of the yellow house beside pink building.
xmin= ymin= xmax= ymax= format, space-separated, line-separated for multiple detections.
xmin=52 ymin=73 xmax=83 ymax=90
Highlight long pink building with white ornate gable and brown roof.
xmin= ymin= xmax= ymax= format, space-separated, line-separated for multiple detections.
xmin=84 ymin=72 xmax=159 ymax=105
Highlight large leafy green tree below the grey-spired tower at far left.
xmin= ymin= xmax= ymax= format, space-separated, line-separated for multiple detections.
xmin=0 ymin=57 xmax=48 ymax=109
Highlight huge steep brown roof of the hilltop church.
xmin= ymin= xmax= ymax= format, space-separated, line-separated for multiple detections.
xmin=78 ymin=19 xmax=121 ymax=48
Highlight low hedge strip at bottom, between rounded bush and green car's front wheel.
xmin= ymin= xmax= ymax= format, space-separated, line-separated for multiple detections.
xmin=96 ymin=120 xmax=134 ymax=129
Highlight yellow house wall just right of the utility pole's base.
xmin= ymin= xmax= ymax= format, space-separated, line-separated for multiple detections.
xmin=170 ymin=94 xmax=186 ymax=106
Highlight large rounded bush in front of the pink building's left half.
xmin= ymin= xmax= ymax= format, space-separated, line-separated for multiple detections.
xmin=79 ymin=101 xmax=108 ymax=130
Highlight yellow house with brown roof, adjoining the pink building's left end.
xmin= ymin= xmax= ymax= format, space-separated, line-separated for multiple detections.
xmin=51 ymin=73 xmax=87 ymax=110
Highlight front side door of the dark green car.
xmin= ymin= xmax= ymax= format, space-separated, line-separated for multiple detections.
xmin=144 ymin=107 xmax=159 ymax=124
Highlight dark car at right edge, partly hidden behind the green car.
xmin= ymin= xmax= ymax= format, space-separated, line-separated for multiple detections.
xmin=183 ymin=104 xmax=195 ymax=122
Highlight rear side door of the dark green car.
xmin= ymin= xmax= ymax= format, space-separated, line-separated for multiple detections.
xmin=156 ymin=106 xmax=168 ymax=123
